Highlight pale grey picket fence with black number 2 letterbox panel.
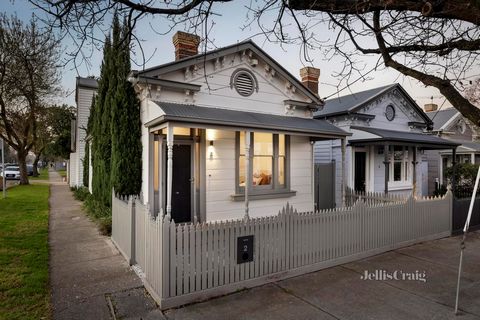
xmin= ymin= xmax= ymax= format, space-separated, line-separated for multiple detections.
xmin=112 ymin=192 xmax=452 ymax=308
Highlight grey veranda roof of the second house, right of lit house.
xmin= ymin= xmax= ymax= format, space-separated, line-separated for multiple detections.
xmin=351 ymin=126 xmax=460 ymax=148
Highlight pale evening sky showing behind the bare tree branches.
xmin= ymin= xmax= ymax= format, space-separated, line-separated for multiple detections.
xmin=0 ymin=0 xmax=468 ymax=108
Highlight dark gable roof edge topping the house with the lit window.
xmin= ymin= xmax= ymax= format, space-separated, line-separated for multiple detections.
xmin=138 ymin=40 xmax=323 ymax=105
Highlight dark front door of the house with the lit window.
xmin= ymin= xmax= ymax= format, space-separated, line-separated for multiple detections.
xmin=168 ymin=144 xmax=192 ymax=223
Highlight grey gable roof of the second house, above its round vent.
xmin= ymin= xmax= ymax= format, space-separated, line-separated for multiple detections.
xmin=315 ymin=83 xmax=431 ymax=124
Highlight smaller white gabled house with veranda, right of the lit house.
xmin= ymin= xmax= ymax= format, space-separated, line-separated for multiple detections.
xmin=315 ymin=84 xmax=458 ymax=206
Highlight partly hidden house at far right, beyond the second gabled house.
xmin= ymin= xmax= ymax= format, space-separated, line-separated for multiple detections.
xmin=425 ymin=103 xmax=480 ymax=194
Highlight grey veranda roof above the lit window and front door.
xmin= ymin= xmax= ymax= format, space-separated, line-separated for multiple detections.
xmin=146 ymin=101 xmax=350 ymax=138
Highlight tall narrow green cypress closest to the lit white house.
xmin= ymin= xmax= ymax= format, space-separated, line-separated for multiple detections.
xmin=111 ymin=22 xmax=142 ymax=195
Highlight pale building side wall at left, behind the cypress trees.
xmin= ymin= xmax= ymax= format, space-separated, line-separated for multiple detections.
xmin=67 ymin=77 xmax=98 ymax=190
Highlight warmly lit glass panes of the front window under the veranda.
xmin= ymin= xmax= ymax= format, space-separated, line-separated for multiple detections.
xmin=237 ymin=132 xmax=289 ymax=193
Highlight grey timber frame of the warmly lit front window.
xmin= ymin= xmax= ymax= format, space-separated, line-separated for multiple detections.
xmin=234 ymin=131 xmax=292 ymax=198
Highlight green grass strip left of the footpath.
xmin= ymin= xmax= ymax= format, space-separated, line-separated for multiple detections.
xmin=0 ymin=185 xmax=51 ymax=319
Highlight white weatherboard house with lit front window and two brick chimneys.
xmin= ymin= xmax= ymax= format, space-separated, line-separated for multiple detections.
xmin=125 ymin=32 xmax=348 ymax=222
